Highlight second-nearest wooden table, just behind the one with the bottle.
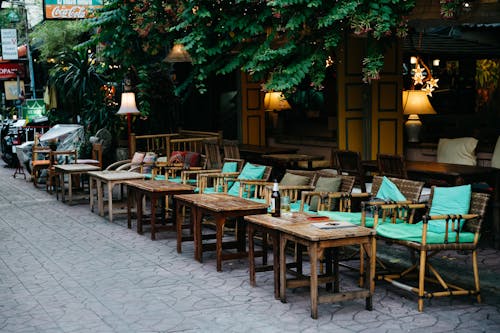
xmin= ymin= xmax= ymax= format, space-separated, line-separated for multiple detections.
xmin=175 ymin=194 xmax=267 ymax=272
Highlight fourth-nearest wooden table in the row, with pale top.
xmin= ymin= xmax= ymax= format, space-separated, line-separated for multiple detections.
xmin=88 ymin=170 xmax=144 ymax=222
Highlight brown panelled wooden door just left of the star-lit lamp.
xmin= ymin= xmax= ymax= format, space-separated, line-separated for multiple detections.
xmin=337 ymin=37 xmax=403 ymax=159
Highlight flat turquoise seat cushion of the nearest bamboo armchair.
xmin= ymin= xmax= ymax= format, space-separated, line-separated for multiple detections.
xmin=377 ymin=222 xmax=474 ymax=244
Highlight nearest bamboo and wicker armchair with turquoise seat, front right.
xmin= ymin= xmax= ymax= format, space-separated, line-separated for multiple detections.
xmin=374 ymin=187 xmax=490 ymax=311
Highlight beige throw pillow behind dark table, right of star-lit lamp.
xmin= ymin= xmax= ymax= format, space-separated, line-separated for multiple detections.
xmin=437 ymin=138 xmax=478 ymax=165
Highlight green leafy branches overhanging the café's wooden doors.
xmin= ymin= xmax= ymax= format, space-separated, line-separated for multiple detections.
xmin=176 ymin=0 xmax=415 ymax=92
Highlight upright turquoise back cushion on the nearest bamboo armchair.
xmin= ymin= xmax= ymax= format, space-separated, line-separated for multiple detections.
xmin=427 ymin=185 xmax=472 ymax=233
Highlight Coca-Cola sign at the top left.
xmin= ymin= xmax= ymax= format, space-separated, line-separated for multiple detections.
xmin=43 ymin=0 xmax=103 ymax=20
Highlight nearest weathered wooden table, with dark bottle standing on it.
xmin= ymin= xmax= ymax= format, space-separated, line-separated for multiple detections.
xmin=245 ymin=213 xmax=376 ymax=319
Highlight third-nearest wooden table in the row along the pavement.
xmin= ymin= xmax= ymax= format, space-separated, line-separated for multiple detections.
xmin=125 ymin=179 xmax=194 ymax=240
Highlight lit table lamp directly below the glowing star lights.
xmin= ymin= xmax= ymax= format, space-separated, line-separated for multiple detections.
xmin=403 ymin=90 xmax=436 ymax=142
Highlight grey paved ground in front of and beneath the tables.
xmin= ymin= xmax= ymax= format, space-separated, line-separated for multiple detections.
xmin=0 ymin=162 xmax=500 ymax=333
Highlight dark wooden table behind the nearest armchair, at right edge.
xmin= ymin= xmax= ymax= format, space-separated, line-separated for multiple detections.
xmin=362 ymin=160 xmax=500 ymax=249
